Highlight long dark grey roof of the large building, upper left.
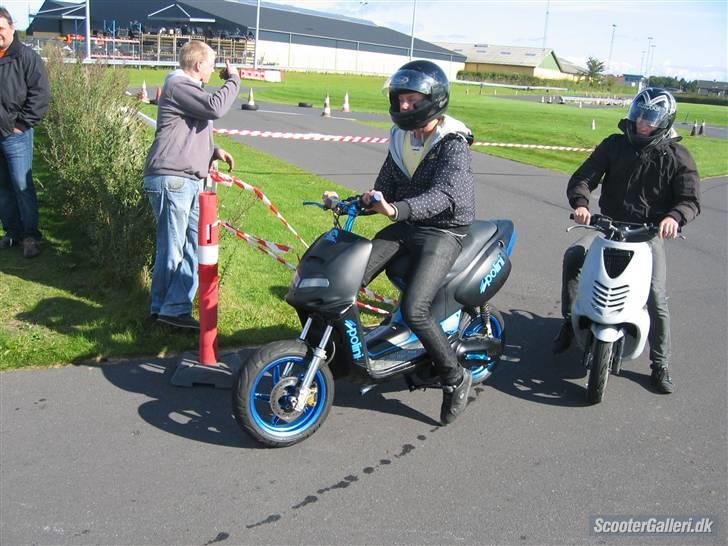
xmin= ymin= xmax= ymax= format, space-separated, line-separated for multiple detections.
xmin=28 ymin=0 xmax=465 ymax=62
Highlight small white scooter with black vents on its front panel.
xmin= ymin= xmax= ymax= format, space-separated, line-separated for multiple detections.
xmin=567 ymin=214 xmax=658 ymax=404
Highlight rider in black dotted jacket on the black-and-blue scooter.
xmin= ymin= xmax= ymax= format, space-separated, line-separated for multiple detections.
xmin=324 ymin=61 xmax=475 ymax=425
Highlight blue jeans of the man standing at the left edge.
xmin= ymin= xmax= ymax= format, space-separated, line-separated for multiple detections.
xmin=0 ymin=129 xmax=42 ymax=241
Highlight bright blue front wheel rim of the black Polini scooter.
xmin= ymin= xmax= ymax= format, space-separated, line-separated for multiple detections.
xmin=249 ymin=356 xmax=328 ymax=439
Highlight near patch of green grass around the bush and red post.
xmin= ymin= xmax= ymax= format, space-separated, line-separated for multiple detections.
xmin=0 ymin=133 xmax=396 ymax=370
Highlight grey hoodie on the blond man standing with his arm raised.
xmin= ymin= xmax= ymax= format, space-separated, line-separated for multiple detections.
xmin=144 ymin=70 xmax=240 ymax=179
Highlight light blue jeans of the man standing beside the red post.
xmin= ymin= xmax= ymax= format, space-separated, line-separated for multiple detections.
xmin=144 ymin=175 xmax=201 ymax=317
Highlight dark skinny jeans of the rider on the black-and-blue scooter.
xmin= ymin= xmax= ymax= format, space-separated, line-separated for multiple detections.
xmin=363 ymin=222 xmax=463 ymax=385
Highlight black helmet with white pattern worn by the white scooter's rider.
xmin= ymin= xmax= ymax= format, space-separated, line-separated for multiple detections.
xmin=627 ymin=87 xmax=677 ymax=146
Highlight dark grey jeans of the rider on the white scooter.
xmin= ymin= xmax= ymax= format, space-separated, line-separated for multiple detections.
xmin=561 ymin=232 xmax=672 ymax=368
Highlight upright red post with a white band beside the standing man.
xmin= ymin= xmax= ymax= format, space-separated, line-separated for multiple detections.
xmin=197 ymin=191 xmax=220 ymax=366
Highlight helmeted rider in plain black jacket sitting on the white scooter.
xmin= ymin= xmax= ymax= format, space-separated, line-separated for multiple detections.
xmin=553 ymin=88 xmax=700 ymax=394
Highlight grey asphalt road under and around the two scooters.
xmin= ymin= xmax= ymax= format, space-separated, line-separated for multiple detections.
xmin=0 ymin=99 xmax=728 ymax=545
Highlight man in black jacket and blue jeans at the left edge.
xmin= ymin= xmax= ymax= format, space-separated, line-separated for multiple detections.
xmin=0 ymin=7 xmax=50 ymax=258
